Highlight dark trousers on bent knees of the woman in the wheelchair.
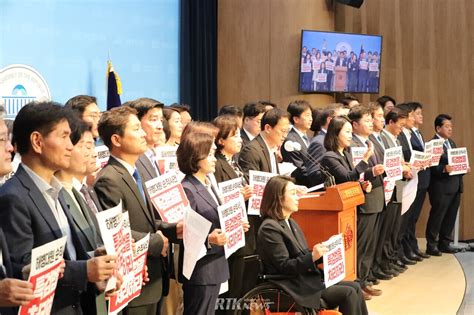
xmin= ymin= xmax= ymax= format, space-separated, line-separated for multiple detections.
xmin=321 ymin=281 xmax=368 ymax=315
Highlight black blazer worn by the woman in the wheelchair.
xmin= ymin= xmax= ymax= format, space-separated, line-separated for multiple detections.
xmin=257 ymin=218 xmax=324 ymax=309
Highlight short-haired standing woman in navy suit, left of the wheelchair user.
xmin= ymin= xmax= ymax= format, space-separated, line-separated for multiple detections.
xmin=176 ymin=133 xmax=250 ymax=315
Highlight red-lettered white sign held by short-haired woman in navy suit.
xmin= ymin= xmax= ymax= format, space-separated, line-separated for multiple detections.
xmin=217 ymin=199 xmax=245 ymax=258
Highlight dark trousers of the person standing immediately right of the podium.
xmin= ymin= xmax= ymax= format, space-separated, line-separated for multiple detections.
xmin=357 ymin=213 xmax=379 ymax=287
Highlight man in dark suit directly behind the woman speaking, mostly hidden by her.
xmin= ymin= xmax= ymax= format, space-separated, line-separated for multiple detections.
xmin=305 ymin=104 xmax=343 ymax=186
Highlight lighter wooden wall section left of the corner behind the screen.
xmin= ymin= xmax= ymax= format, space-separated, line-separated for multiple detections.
xmin=218 ymin=0 xmax=334 ymax=108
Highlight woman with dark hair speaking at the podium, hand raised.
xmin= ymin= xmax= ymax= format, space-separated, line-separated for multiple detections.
xmin=321 ymin=116 xmax=380 ymax=192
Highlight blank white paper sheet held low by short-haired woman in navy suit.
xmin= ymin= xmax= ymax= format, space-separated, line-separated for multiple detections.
xmin=183 ymin=208 xmax=212 ymax=279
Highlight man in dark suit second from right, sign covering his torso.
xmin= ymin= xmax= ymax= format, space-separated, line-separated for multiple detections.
xmin=403 ymin=103 xmax=431 ymax=258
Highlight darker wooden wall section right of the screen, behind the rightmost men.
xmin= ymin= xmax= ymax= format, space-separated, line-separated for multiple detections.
xmin=335 ymin=0 xmax=474 ymax=239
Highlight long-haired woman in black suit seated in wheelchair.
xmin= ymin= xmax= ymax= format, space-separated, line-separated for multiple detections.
xmin=257 ymin=176 xmax=368 ymax=315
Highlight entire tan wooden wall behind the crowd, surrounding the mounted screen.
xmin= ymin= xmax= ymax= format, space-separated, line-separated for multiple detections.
xmin=218 ymin=0 xmax=474 ymax=239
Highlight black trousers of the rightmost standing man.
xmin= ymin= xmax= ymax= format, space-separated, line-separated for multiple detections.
xmin=426 ymin=191 xmax=461 ymax=246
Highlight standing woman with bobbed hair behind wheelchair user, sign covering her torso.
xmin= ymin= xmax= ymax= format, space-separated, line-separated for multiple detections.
xmin=213 ymin=115 xmax=255 ymax=308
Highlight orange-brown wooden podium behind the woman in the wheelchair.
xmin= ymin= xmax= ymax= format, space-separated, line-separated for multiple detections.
xmin=291 ymin=182 xmax=365 ymax=280
